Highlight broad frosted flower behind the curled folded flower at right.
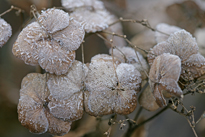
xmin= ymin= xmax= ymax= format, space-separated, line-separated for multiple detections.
xmin=148 ymin=30 xmax=205 ymax=80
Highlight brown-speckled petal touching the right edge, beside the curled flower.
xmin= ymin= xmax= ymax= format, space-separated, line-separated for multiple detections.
xmin=181 ymin=53 xmax=205 ymax=80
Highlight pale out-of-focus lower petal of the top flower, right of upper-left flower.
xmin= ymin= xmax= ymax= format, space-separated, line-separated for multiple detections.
xmin=70 ymin=9 xmax=111 ymax=33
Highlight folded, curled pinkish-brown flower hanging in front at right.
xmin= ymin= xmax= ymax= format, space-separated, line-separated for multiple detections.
xmin=149 ymin=53 xmax=183 ymax=107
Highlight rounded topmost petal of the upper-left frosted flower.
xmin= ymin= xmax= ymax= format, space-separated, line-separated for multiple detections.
xmin=38 ymin=8 xmax=69 ymax=33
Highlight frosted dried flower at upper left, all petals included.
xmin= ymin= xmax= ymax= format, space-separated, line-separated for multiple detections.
xmin=12 ymin=8 xmax=85 ymax=75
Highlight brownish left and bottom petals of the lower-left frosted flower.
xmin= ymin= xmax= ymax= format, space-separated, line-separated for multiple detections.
xmin=18 ymin=73 xmax=71 ymax=135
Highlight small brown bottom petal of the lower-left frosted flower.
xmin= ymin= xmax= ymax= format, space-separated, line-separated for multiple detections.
xmin=46 ymin=112 xmax=72 ymax=136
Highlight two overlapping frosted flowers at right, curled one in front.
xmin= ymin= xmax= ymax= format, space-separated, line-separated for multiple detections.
xmin=148 ymin=29 xmax=205 ymax=107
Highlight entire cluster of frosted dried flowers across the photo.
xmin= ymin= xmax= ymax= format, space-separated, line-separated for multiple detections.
xmin=7 ymin=0 xmax=205 ymax=135
